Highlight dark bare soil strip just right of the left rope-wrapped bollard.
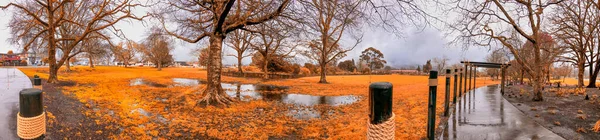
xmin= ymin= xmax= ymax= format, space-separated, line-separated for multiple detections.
xmin=43 ymin=82 xmax=117 ymax=139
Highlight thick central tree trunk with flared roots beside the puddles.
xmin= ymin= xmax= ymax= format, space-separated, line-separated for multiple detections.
xmin=199 ymin=34 xmax=233 ymax=105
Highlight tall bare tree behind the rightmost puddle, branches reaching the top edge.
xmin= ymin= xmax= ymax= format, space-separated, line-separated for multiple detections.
xmin=300 ymin=0 xmax=364 ymax=83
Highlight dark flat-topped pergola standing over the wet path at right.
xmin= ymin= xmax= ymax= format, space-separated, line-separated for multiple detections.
xmin=455 ymin=61 xmax=510 ymax=94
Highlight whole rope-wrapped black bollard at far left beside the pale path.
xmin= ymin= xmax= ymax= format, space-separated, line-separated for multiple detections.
xmin=17 ymin=88 xmax=46 ymax=139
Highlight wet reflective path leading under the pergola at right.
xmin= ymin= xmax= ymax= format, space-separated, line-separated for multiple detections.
xmin=440 ymin=85 xmax=563 ymax=140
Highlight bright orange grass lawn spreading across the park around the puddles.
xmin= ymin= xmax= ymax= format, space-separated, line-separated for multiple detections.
xmin=21 ymin=66 xmax=499 ymax=139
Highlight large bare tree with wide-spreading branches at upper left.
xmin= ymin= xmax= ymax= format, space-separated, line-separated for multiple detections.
xmin=0 ymin=0 xmax=148 ymax=83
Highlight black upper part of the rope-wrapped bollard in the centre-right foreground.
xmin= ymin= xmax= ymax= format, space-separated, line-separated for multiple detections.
xmin=369 ymin=82 xmax=393 ymax=124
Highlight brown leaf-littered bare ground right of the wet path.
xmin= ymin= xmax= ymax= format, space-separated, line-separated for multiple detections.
xmin=504 ymin=85 xmax=600 ymax=140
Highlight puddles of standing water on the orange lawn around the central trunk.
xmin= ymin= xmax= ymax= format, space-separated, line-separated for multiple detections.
xmin=131 ymin=78 xmax=359 ymax=119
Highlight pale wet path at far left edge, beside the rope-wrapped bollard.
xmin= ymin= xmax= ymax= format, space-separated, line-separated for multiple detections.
xmin=0 ymin=68 xmax=32 ymax=140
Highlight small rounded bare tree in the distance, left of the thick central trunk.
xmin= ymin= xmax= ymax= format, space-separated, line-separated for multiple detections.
xmin=136 ymin=27 xmax=173 ymax=71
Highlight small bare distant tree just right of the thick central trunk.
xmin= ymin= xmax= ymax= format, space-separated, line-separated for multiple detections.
xmin=227 ymin=30 xmax=255 ymax=73
